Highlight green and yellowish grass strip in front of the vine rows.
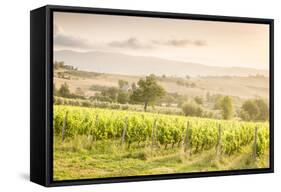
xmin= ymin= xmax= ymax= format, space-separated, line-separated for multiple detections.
xmin=51 ymin=136 xmax=269 ymax=180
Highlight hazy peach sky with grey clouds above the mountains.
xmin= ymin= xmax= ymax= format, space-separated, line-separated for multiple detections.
xmin=54 ymin=12 xmax=269 ymax=69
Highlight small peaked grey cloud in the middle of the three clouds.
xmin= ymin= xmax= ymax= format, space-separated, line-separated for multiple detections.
xmin=108 ymin=37 xmax=152 ymax=49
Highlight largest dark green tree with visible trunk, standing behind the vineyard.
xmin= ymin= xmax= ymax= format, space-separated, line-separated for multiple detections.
xmin=131 ymin=75 xmax=165 ymax=111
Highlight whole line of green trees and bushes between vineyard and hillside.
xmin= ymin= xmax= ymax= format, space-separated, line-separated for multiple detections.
xmin=54 ymin=75 xmax=269 ymax=121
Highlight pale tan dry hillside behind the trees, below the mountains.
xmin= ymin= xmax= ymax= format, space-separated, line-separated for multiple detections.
xmin=54 ymin=67 xmax=269 ymax=98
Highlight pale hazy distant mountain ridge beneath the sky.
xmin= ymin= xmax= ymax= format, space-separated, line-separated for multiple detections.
xmin=54 ymin=50 xmax=269 ymax=77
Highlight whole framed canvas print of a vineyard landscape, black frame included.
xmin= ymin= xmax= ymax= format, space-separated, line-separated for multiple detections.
xmin=30 ymin=5 xmax=274 ymax=186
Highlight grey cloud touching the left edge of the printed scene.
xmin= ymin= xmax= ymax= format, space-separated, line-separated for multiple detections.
xmin=54 ymin=25 xmax=92 ymax=48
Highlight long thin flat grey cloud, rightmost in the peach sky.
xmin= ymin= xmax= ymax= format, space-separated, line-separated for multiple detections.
xmin=152 ymin=39 xmax=207 ymax=47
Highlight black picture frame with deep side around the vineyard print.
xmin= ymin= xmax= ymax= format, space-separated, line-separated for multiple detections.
xmin=30 ymin=5 xmax=274 ymax=187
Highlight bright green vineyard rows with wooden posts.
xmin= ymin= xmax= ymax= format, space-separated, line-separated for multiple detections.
xmin=53 ymin=105 xmax=269 ymax=158
